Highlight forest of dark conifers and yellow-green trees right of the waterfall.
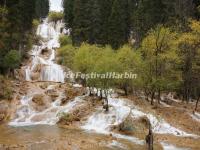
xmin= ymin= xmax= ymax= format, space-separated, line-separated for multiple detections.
xmin=60 ymin=0 xmax=200 ymax=105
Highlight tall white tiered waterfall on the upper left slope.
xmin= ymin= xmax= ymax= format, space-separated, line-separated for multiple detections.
xmin=25 ymin=19 xmax=65 ymax=83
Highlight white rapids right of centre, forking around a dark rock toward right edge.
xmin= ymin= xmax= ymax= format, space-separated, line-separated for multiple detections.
xmin=82 ymin=98 xmax=197 ymax=144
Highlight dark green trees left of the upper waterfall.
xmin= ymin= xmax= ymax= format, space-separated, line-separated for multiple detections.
xmin=0 ymin=0 xmax=49 ymax=73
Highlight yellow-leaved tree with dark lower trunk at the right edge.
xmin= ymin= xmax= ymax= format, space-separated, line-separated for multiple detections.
xmin=177 ymin=20 xmax=200 ymax=102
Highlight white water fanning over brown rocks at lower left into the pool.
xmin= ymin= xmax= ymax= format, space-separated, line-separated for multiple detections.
xmin=9 ymin=90 xmax=84 ymax=126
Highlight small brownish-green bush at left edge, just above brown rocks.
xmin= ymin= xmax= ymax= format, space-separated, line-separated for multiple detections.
xmin=0 ymin=76 xmax=13 ymax=100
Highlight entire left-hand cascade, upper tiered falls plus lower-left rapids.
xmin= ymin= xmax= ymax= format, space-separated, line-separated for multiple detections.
xmin=9 ymin=16 xmax=72 ymax=126
